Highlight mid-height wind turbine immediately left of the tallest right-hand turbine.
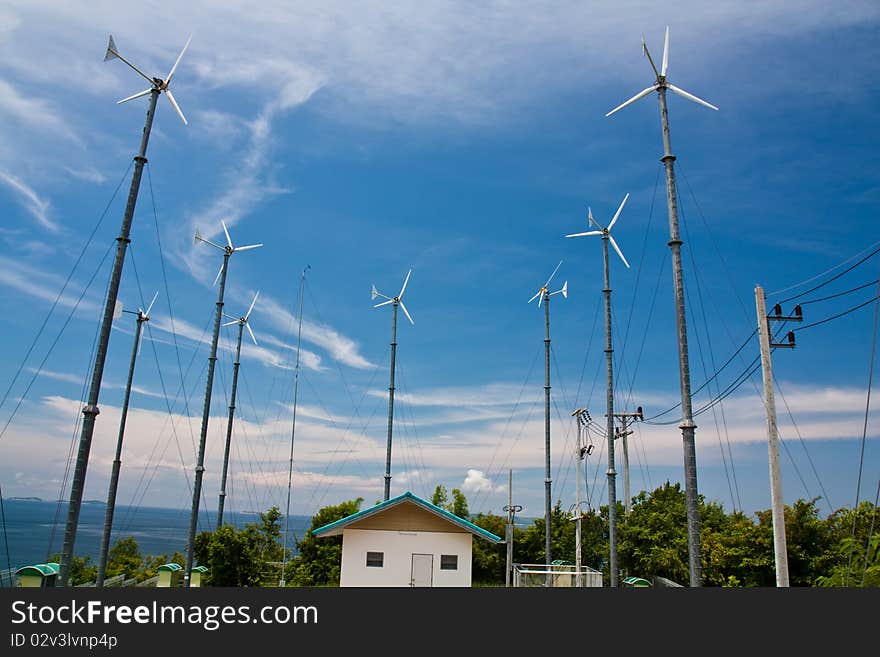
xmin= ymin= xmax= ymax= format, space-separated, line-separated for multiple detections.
xmin=566 ymin=194 xmax=629 ymax=586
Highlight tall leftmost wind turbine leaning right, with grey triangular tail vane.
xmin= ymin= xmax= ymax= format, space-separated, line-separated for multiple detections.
xmin=58 ymin=36 xmax=192 ymax=586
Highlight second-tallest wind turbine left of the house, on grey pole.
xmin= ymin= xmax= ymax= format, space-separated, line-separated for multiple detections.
xmin=183 ymin=221 xmax=263 ymax=587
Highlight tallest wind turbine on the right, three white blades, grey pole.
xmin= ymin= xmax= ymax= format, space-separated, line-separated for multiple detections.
xmin=605 ymin=27 xmax=718 ymax=586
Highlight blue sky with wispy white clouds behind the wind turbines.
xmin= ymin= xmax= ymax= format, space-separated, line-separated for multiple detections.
xmin=0 ymin=1 xmax=880 ymax=532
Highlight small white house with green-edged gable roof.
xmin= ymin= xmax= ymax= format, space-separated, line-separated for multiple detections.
xmin=312 ymin=491 xmax=504 ymax=587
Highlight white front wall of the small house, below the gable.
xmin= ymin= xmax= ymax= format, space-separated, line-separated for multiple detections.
xmin=339 ymin=529 xmax=473 ymax=587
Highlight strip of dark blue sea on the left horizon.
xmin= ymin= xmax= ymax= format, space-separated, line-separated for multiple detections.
xmin=0 ymin=499 xmax=312 ymax=571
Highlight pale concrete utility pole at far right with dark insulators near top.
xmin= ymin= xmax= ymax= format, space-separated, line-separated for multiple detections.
xmin=755 ymin=285 xmax=803 ymax=587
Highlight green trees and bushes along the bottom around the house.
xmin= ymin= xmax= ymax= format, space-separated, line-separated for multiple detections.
xmin=56 ymin=482 xmax=880 ymax=587
